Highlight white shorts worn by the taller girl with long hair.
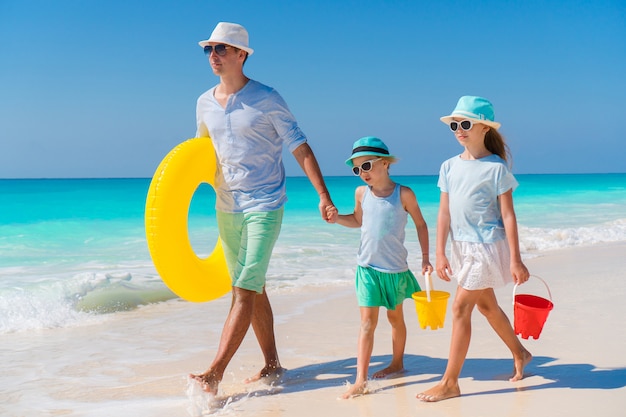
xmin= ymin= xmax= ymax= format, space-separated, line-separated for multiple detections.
xmin=450 ymin=239 xmax=513 ymax=290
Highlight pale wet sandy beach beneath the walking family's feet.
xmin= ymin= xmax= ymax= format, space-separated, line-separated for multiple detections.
xmin=0 ymin=243 xmax=626 ymax=417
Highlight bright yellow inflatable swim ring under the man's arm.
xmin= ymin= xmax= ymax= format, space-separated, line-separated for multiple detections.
xmin=145 ymin=138 xmax=231 ymax=302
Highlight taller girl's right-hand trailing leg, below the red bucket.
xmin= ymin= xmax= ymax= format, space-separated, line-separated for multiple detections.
xmin=477 ymin=288 xmax=533 ymax=381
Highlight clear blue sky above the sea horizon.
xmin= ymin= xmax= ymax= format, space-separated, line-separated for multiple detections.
xmin=0 ymin=0 xmax=626 ymax=178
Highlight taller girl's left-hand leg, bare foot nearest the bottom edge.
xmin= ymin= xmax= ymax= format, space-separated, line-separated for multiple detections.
xmin=417 ymin=287 xmax=483 ymax=402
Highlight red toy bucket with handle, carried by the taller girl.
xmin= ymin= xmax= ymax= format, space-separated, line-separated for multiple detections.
xmin=513 ymin=275 xmax=554 ymax=340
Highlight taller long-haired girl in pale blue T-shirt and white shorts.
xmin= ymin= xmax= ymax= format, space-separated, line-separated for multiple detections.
xmin=417 ymin=96 xmax=532 ymax=402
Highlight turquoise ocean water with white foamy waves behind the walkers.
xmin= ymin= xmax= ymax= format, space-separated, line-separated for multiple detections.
xmin=0 ymin=174 xmax=626 ymax=337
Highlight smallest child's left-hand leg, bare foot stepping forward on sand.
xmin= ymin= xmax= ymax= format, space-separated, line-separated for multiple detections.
xmin=342 ymin=307 xmax=378 ymax=398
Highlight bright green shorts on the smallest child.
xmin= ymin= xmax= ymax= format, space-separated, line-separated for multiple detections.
xmin=356 ymin=266 xmax=421 ymax=310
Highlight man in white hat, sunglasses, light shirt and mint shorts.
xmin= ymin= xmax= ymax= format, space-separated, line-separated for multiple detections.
xmin=190 ymin=22 xmax=333 ymax=394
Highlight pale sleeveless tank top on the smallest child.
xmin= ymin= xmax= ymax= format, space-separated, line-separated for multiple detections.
xmin=357 ymin=184 xmax=409 ymax=273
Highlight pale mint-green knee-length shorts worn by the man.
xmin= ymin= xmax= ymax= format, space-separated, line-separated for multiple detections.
xmin=217 ymin=208 xmax=284 ymax=294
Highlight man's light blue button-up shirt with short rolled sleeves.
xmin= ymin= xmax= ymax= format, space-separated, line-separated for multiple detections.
xmin=196 ymin=80 xmax=307 ymax=213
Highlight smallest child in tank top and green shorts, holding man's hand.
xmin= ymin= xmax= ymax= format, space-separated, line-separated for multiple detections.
xmin=328 ymin=136 xmax=433 ymax=398
